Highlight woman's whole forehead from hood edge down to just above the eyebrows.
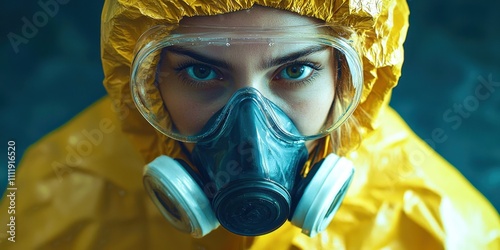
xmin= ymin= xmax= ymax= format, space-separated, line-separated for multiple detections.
xmin=173 ymin=5 xmax=325 ymax=64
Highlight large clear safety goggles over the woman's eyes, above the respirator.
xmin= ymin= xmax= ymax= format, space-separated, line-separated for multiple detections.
xmin=130 ymin=25 xmax=363 ymax=142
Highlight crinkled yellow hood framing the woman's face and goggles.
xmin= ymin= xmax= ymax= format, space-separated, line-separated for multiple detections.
xmin=101 ymin=0 xmax=409 ymax=161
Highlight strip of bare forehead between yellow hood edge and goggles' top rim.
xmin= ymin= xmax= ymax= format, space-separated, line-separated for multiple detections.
xmin=180 ymin=6 xmax=323 ymax=28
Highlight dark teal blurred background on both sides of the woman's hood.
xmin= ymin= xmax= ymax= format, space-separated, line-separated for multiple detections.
xmin=0 ymin=0 xmax=500 ymax=213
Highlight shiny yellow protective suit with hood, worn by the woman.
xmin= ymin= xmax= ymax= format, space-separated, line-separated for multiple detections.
xmin=0 ymin=0 xmax=500 ymax=250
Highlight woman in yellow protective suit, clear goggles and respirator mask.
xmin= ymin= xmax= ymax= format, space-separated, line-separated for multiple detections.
xmin=2 ymin=1 xmax=500 ymax=249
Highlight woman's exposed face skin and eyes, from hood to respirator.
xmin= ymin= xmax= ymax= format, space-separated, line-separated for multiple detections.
xmin=158 ymin=6 xmax=336 ymax=149
